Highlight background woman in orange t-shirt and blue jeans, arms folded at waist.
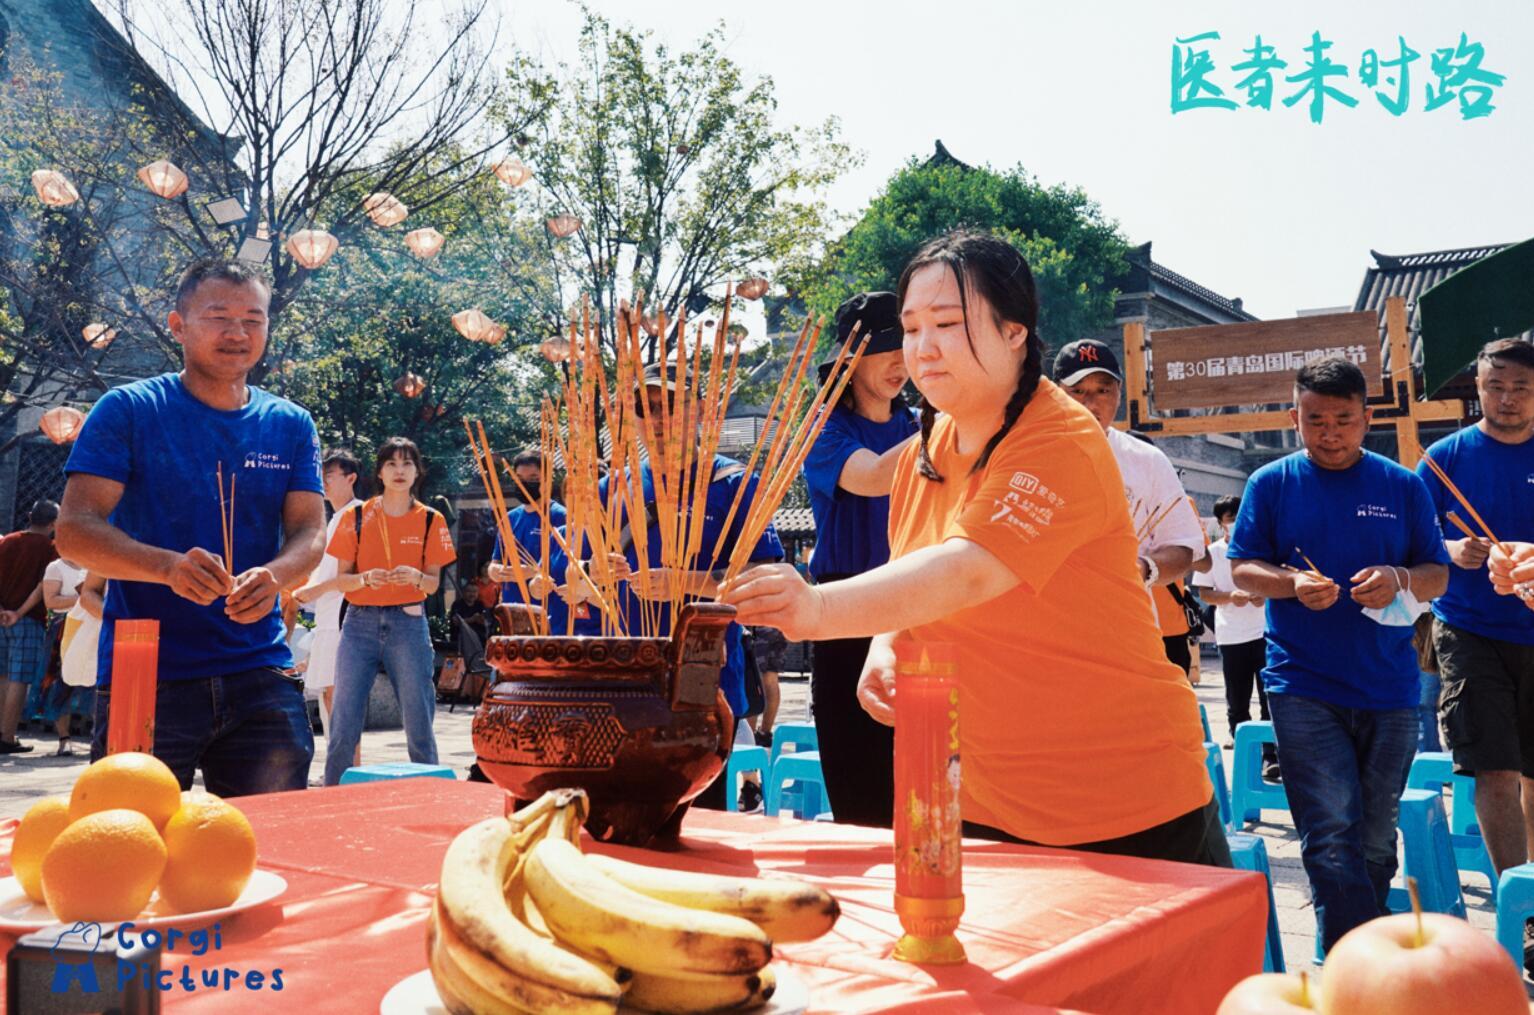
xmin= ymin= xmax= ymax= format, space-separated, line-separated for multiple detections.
xmin=316 ymin=437 xmax=457 ymax=787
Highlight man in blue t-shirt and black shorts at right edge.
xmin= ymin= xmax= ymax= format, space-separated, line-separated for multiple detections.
xmin=1417 ymin=339 xmax=1534 ymax=874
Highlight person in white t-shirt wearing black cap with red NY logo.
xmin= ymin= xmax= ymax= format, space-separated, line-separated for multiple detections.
xmin=1054 ymin=339 xmax=1206 ymax=673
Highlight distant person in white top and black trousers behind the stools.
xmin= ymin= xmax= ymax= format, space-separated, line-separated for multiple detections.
xmin=1193 ymin=497 xmax=1279 ymax=782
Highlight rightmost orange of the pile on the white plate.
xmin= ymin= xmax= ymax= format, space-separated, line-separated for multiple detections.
xmin=160 ymin=796 xmax=256 ymax=912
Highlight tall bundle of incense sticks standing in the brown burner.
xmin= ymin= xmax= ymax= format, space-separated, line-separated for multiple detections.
xmin=471 ymin=294 xmax=864 ymax=636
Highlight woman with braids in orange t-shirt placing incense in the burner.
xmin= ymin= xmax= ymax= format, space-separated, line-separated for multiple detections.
xmin=724 ymin=232 xmax=1230 ymax=866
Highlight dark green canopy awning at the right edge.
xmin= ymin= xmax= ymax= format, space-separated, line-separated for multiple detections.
xmin=1417 ymin=239 xmax=1534 ymax=399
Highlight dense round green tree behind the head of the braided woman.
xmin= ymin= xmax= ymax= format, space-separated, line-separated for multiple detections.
xmin=799 ymin=159 xmax=1127 ymax=357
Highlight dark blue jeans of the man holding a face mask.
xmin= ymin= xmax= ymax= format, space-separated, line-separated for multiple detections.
xmin=1267 ymin=695 xmax=1420 ymax=949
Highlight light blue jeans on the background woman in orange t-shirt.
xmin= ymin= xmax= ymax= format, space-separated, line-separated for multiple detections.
xmin=325 ymin=606 xmax=437 ymax=787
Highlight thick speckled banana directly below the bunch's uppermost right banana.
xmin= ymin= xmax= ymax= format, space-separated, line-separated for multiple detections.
xmin=523 ymin=831 xmax=772 ymax=977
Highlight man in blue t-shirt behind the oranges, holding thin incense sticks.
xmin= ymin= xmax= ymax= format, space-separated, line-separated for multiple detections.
xmin=57 ymin=261 xmax=325 ymax=796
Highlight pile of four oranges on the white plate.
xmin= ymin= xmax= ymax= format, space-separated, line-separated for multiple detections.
xmin=11 ymin=753 xmax=256 ymax=923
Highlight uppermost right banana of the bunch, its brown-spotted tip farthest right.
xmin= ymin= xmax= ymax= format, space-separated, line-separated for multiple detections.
xmin=586 ymin=854 xmax=841 ymax=944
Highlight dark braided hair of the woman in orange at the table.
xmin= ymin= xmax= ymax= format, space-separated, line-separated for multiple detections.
xmin=896 ymin=228 xmax=1045 ymax=483
